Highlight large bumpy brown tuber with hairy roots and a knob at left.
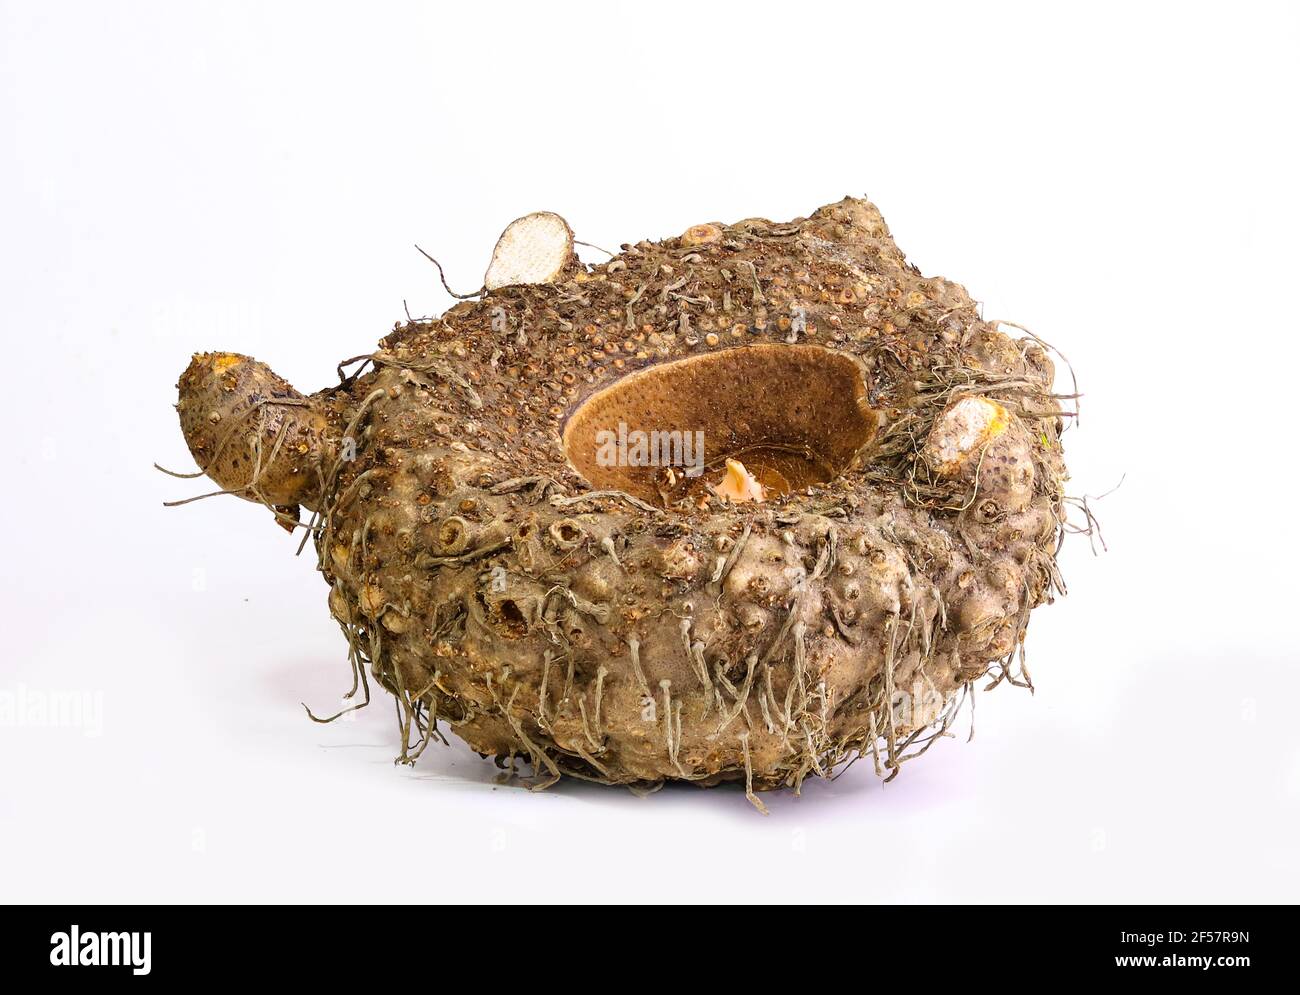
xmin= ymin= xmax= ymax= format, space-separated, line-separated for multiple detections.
xmin=172 ymin=199 xmax=1065 ymax=789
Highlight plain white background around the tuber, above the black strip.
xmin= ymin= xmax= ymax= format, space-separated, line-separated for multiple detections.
xmin=0 ymin=0 xmax=1300 ymax=901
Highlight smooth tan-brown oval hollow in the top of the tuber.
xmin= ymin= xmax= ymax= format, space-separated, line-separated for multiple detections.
xmin=564 ymin=343 xmax=879 ymax=503
